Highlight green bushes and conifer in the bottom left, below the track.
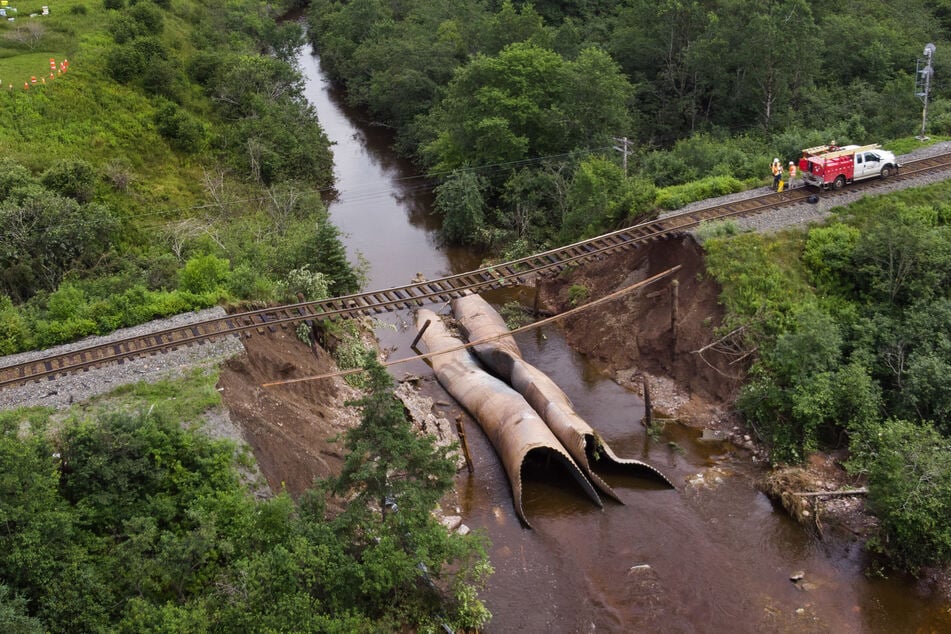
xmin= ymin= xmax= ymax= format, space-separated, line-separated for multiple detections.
xmin=0 ymin=359 xmax=491 ymax=634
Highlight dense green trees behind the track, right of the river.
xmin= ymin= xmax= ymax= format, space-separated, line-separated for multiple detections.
xmin=308 ymin=0 xmax=951 ymax=256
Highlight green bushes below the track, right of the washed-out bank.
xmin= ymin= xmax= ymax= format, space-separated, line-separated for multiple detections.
xmin=705 ymin=182 xmax=951 ymax=572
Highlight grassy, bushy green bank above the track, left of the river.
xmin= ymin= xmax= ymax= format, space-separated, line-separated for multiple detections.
xmin=0 ymin=0 xmax=359 ymax=354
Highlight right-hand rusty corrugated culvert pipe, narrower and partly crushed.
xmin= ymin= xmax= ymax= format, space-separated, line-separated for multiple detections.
xmin=451 ymin=295 xmax=673 ymax=502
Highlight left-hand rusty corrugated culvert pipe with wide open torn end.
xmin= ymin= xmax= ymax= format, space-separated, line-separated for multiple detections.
xmin=416 ymin=309 xmax=602 ymax=528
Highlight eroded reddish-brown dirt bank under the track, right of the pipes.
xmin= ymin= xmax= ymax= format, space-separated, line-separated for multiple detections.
xmin=539 ymin=236 xmax=745 ymax=426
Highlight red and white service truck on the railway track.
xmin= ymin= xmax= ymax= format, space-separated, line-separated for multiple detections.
xmin=799 ymin=143 xmax=901 ymax=189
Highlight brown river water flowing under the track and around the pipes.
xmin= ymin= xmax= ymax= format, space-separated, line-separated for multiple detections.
xmin=299 ymin=51 xmax=951 ymax=633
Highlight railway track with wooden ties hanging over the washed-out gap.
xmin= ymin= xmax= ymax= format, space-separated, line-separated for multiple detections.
xmin=0 ymin=154 xmax=951 ymax=389
